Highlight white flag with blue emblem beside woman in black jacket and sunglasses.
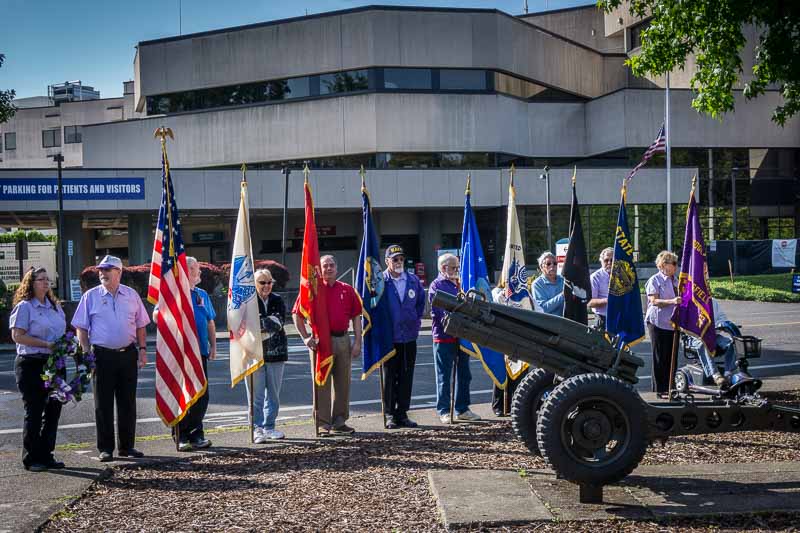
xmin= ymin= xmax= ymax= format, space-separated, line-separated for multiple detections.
xmin=228 ymin=180 xmax=264 ymax=387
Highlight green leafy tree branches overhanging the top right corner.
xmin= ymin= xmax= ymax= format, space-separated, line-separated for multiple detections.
xmin=598 ymin=0 xmax=800 ymax=126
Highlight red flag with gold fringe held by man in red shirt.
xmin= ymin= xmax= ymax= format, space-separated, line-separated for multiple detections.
xmin=292 ymin=180 xmax=333 ymax=386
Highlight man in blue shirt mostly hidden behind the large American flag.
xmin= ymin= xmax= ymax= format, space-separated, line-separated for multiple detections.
xmin=153 ymin=257 xmax=217 ymax=452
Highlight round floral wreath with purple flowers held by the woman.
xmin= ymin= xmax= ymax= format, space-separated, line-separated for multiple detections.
xmin=42 ymin=331 xmax=95 ymax=403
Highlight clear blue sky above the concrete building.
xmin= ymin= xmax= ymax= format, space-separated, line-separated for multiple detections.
xmin=0 ymin=0 xmax=594 ymax=98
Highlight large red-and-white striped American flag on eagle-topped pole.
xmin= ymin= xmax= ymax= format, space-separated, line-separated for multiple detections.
xmin=147 ymin=147 xmax=206 ymax=426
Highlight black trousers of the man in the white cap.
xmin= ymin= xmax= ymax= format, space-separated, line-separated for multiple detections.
xmin=92 ymin=344 xmax=139 ymax=453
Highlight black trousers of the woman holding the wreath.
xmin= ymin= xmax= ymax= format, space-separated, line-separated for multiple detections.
xmin=14 ymin=355 xmax=61 ymax=466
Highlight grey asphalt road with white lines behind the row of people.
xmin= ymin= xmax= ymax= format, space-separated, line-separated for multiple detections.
xmin=0 ymin=302 xmax=800 ymax=451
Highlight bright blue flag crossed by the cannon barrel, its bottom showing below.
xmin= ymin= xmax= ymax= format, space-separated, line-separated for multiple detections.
xmin=459 ymin=178 xmax=507 ymax=389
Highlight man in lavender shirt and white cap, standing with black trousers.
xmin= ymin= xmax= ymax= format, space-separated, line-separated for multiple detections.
xmin=72 ymin=255 xmax=150 ymax=463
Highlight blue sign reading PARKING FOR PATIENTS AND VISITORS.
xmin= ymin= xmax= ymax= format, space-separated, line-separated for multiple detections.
xmin=0 ymin=178 xmax=144 ymax=202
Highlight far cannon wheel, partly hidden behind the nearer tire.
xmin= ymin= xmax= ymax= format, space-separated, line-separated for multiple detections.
xmin=511 ymin=368 xmax=555 ymax=455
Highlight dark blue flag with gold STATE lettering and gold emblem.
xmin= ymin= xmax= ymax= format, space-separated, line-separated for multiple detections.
xmin=606 ymin=187 xmax=644 ymax=346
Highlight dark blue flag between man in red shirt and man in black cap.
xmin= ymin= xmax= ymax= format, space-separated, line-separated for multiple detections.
xmin=356 ymin=174 xmax=395 ymax=379
